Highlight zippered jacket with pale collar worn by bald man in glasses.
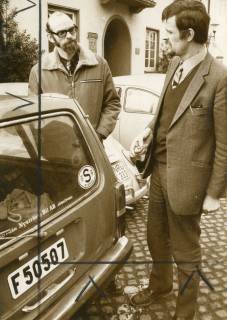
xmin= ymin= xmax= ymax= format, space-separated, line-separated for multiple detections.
xmin=29 ymin=45 xmax=121 ymax=137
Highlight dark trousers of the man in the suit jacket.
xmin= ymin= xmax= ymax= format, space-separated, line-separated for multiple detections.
xmin=147 ymin=164 xmax=201 ymax=319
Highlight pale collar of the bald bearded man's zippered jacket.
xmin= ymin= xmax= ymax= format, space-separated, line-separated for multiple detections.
xmin=42 ymin=44 xmax=98 ymax=71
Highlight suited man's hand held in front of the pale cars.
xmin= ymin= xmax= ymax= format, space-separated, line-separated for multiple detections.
xmin=130 ymin=128 xmax=152 ymax=158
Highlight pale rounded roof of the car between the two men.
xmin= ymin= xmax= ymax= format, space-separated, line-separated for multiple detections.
xmin=114 ymin=73 xmax=165 ymax=95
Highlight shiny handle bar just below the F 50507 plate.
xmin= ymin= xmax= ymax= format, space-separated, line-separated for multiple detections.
xmin=22 ymin=269 xmax=76 ymax=313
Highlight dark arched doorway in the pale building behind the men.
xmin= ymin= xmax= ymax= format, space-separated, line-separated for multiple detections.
xmin=104 ymin=18 xmax=131 ymax=76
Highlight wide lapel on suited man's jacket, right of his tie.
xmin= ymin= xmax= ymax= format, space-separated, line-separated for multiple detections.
xmin=169 ymin=53 xmax=213 ymax=129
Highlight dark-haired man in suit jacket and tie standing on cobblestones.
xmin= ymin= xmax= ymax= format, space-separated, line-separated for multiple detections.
xmin=131 ymin=0 xmax=227 ymax=320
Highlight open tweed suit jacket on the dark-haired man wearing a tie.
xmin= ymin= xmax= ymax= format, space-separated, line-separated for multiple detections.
xmin=143 ymin=53 xmax=227 ymax=215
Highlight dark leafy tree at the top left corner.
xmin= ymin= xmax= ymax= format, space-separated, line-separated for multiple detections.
xmin=0 ymin=0 xmax=38 ymax=82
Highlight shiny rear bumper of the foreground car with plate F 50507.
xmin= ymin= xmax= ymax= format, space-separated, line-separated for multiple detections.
xmin=39 ymin=236 xmax=132 ymax=320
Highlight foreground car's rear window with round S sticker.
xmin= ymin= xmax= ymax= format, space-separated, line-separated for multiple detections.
xmin=0 ymin=115 xmax=97 ymax=246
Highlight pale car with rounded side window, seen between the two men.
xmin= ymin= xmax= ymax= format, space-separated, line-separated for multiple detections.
xmin=112 ymin=73 xmax=165 ymax=150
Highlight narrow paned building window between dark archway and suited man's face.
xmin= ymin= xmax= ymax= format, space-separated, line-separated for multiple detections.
xmin=145 ymin=28 xmax=159 ymax=72
